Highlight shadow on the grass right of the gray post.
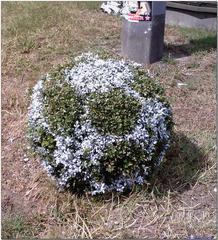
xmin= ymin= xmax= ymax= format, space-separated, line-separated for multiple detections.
xmin=164 ymin=34 xmax=217 ymax=58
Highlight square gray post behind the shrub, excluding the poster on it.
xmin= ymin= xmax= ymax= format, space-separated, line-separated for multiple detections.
xmin=121 ymin=1 xmax=166 ymax=64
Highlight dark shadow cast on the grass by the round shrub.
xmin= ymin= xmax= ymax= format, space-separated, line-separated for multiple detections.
xmin=151 ymin=133 xmax=205 ymax=196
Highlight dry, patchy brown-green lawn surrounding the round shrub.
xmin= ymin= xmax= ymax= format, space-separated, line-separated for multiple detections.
xmin=1 ymin=2 xmax=216 ymax=239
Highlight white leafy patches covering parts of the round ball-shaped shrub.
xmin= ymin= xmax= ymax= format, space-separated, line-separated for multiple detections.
xmin=28 ymin=53 xmax=171 ymax=195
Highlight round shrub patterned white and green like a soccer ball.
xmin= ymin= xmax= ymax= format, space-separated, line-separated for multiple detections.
xmin=28 ymin=53 xmax=172 ymax=195
